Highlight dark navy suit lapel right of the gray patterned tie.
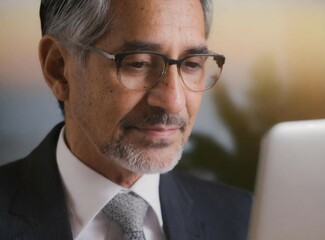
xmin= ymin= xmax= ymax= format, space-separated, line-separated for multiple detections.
xmin=159 ymin=173 xmax=204 ymax=240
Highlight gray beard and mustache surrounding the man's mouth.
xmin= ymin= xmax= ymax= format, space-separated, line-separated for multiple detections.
xmin=104 ymin=108 xmax=188 ymax=175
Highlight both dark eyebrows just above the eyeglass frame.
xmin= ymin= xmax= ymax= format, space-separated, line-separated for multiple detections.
xmin=119 ymin=40 xmax=209 ymax=55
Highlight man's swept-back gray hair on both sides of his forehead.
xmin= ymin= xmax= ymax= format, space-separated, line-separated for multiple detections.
xmin=40 ymin=0 xmax=213 ymax=57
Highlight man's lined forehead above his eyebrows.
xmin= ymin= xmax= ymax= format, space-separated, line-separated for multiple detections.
xmin=98 ymin=0 xmax=205 ymax=53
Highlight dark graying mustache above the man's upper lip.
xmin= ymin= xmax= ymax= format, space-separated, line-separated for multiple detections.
xmin=121 ymin=109 xmax=188 ymax=129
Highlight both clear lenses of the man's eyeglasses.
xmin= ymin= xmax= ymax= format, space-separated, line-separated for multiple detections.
xmin=118 ymin=53 xmax=221 ymax=91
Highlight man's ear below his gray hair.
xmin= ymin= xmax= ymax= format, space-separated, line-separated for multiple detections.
xmin=38 ymin=35 xmax=69 ymax=102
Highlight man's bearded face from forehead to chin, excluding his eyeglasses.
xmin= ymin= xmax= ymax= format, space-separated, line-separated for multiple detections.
xmin=65 ymin=0 xmax=206 ymax=174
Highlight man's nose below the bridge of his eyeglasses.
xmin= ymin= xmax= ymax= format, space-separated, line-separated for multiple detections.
xmin=147 ymin=65 xmax=186 ymax=114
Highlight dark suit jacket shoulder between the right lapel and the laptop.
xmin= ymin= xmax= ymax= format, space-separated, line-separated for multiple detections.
xmin=163 ymin=172 xmax=252 ymax=239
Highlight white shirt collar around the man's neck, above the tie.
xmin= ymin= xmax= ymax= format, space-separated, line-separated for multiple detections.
xmin=57 ymin=128 xmax=163 ymax=236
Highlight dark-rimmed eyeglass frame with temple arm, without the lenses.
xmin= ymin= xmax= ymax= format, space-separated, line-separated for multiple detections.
xmin=79 ymin=44 xmax=226 ymax=92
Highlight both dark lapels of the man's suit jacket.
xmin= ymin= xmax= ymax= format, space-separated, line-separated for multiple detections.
xmin=8 ymin=125 xmax=204 ymax=240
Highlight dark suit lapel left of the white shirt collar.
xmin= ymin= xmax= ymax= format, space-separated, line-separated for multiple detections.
xmin=10 ymin=125 xmax=72 ymax=240
